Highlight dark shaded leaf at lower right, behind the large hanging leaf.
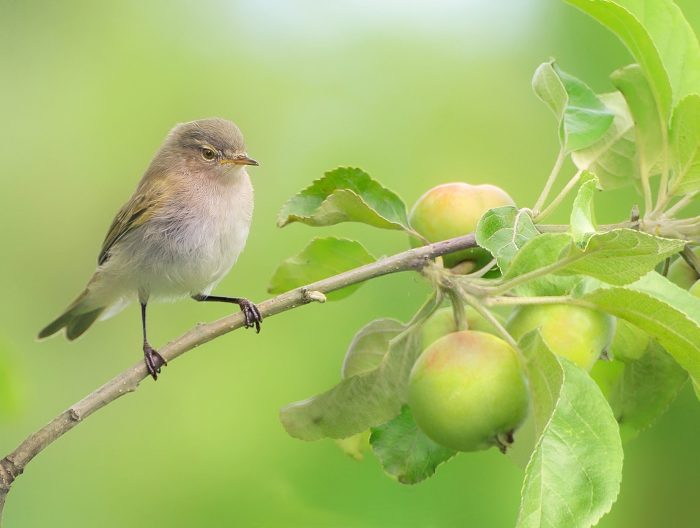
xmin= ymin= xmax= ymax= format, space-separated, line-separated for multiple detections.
xmin=610 ymin=341 xmax=688 ymax=441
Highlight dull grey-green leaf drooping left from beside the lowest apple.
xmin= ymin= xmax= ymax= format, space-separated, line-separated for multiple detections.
xmin=280 ymin=325 xmax=421 ymax=440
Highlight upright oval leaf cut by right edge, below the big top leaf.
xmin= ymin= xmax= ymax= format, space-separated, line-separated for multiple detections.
xmin=669 ymin=95 xmax=700 ymax=196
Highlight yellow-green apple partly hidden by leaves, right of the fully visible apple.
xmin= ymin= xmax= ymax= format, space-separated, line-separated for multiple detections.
xmin=506 ymin=304 xmax=615 ymax=371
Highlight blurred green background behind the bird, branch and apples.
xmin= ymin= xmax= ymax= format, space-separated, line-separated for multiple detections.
xmin=0 ymin=0 xmax=700 ymax=528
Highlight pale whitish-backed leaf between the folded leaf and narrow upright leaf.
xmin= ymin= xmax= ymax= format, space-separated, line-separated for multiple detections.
xmin=571 ymin=92 xmax=639 ymax=189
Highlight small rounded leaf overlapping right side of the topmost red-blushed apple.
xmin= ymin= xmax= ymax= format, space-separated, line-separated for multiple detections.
xmin=476 ymin=205 xmax=539 ymax=271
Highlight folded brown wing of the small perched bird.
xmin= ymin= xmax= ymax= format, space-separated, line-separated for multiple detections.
xmin=97 ymin=180 xmax=166 ymax=265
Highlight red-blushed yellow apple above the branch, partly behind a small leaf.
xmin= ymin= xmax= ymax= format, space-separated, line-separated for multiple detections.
xmin=409 ymin=182 xmax=514 ymax=268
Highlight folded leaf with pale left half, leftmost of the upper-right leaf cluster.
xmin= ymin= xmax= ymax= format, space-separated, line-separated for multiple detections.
xmin=532 ymin=61 xmax=613 ymax=152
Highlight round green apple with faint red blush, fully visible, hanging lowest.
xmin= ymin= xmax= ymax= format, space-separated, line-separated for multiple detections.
xmin=408 ymin=330 xmax=528 ymax=451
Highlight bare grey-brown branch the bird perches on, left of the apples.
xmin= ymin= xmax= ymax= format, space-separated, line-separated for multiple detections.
xmin=0 ymin=234 xmax=476 ymax=525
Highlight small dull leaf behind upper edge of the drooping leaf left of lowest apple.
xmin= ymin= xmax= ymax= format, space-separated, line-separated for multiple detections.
xmin=341 ymin=319 xmax=406 ymax=379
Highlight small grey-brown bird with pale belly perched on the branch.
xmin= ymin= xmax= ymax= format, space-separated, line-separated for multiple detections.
xmin=38 ymin=118 xmax=262 ymax=380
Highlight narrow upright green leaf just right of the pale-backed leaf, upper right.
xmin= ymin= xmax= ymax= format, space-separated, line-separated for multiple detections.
xmin=610 ymin=64 xmax=668 ymax=172
